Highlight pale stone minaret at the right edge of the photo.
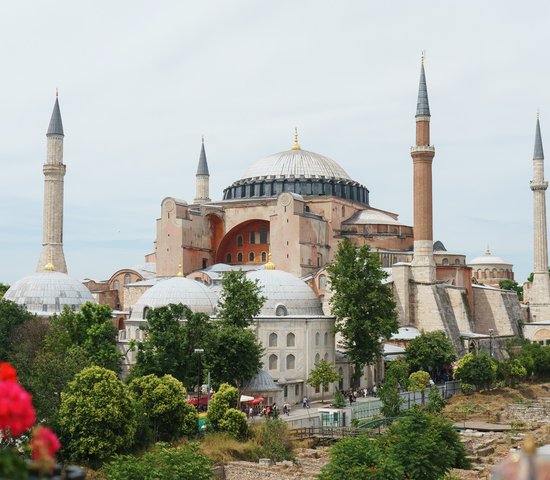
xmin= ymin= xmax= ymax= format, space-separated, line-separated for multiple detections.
xmin=529 ymin=115 xmax=550 ymax=321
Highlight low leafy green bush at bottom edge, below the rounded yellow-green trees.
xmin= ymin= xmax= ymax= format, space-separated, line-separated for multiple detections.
xmin=103 ymin=443 xmax=212 ymax=480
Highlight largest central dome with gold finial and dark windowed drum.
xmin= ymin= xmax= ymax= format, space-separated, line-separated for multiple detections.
xmin=223 ymin=138 xmax=369 ymax=205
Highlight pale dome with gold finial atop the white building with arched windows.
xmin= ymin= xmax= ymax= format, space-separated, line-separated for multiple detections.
xmin=247 ymin=270 xmax=323 ymax=316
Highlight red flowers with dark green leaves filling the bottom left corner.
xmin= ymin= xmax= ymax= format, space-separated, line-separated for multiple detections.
xmin=0 ymin=362 xmax=61 ymax=479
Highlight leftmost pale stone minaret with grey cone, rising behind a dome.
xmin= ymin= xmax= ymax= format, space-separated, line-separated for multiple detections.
xmin=36 ymin=94 xmax=67 ymax=273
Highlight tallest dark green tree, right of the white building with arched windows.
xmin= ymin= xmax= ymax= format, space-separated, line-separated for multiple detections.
xmin=327 ymin=238 xmax=399 ymax=384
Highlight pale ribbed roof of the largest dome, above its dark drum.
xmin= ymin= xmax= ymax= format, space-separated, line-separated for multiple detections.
xmin=241 ymin=150 xmax=351 ymax=180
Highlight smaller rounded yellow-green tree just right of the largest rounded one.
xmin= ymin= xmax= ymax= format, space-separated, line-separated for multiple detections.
xmin=128 ymin=375 xmax=199 ymax=442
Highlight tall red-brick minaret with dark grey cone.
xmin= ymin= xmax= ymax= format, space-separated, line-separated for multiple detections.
xmin=411 ymin=54 xmax=435 ymax=283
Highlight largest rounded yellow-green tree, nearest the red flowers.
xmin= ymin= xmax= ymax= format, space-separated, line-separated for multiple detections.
xmin=59 ymin=367 xmax=137 ymax=467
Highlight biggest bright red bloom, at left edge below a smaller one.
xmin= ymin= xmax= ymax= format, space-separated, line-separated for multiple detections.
xmin=0 ymin=380 xmax=36 ymax=437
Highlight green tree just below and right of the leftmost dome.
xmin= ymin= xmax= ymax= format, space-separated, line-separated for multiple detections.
xmin=45 ymin=302 xmax=122 ymax=373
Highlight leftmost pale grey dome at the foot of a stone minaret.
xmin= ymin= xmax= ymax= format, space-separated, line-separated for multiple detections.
xmin=4 ymin=271 xmax=96 ymax=317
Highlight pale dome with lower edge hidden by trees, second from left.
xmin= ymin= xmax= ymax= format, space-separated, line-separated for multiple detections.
xmin=131 ymin=277 xmax=217 ymax=320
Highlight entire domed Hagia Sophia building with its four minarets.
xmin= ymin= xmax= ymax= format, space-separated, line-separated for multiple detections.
xmin=5 ymin=61 xmax=550 ymax=403
